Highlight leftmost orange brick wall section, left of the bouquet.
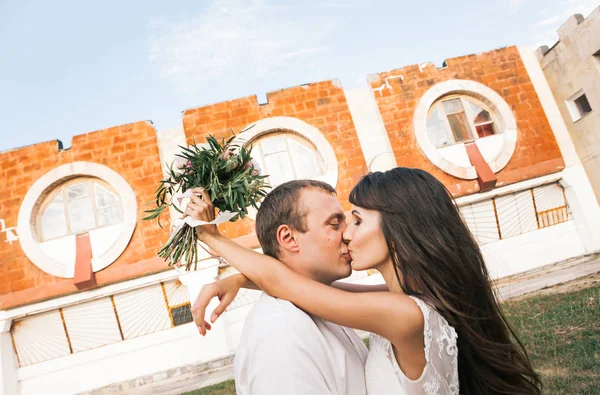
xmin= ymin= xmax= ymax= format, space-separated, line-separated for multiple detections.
xmin=0 ymin=122 xmax=168 ymax=310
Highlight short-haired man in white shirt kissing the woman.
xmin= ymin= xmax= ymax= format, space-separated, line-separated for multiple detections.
xmin=192 ymin=180 xmax=367 ymax=395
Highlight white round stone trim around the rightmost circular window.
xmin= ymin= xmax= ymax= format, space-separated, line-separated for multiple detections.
xmin=413 ymin=80 xmax=517 ymax=180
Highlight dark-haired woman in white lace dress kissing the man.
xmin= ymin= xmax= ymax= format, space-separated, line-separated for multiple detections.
xmin=186 ymin=167 xmax=541 ymax=394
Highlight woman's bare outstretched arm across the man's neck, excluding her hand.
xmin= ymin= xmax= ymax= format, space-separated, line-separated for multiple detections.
xmin=198 ymin=231 xmax=423 ymax=342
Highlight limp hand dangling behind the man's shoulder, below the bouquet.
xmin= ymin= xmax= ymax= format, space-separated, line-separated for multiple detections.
xmin=192 ymin=274 xmax=246 ymax=336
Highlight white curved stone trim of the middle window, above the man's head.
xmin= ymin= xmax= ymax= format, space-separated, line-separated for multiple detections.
xmin=232 ymin=117 xmax=338 ymax=188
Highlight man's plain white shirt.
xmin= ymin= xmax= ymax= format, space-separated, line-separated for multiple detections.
xmin=234 ymin=293 xmax=368 ymax=395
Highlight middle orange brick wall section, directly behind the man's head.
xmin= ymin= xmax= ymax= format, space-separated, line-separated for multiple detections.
xmin=183 ymin=81 xmax=367 ymax=238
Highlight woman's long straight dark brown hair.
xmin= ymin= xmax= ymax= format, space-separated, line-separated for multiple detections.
xmin=350 ymin=167 xmax=541 ymax=394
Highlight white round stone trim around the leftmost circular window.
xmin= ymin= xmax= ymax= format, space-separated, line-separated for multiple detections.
xmin=17 ymin=162 xmax=137 ymax=278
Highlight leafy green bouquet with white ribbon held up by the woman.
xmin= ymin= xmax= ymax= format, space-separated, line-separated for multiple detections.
xmin=143 ymin=134 xmax=270 ymax=270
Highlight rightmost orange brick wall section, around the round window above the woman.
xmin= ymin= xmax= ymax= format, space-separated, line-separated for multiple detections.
xmin=371 ymin=47 xmax=564 ymax=196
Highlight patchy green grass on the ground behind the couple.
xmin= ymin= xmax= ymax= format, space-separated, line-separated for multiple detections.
xmin=186 ymin=284 xmax=600 ymax=395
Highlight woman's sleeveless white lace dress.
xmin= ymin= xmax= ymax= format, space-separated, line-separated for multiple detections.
xmin=365 ymin=296 xmax=458 ymax=395
